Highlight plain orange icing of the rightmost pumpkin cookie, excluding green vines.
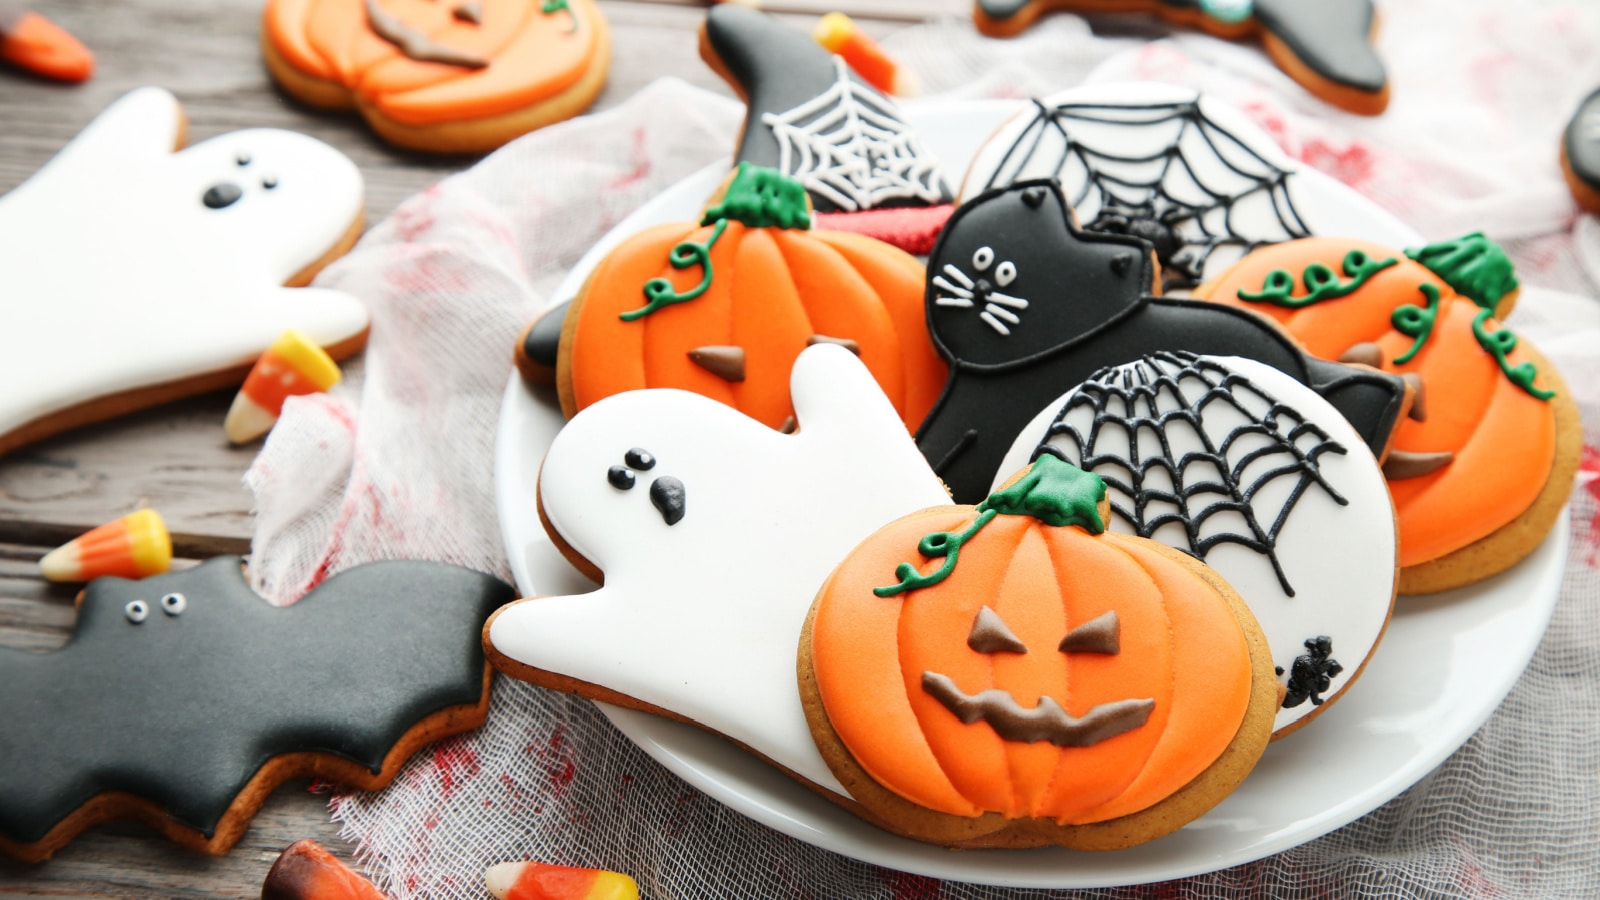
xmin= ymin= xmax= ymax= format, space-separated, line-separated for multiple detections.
xmin=1200 ymin=239 xmax=1555 ymax=567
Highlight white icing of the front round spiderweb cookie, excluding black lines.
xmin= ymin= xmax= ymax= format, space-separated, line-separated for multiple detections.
xmin=995 ymin=357 xmax=1397 ymax=732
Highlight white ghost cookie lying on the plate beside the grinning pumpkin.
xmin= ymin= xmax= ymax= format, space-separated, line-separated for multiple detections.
xmin=483 ymin=346 xmax=950 ymax=791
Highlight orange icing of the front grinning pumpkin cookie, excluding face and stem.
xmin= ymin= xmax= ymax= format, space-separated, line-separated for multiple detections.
xmin=811 ymin=506 xmax=1253 ymax=825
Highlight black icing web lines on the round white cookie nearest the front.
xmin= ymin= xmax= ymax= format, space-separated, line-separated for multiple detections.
xmin=1034 ymin=352 xmax=1349 ymax=597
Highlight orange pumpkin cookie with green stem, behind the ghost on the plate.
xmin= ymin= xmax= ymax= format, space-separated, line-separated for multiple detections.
xmin=557 ymin=163 xmax=946 ymax=429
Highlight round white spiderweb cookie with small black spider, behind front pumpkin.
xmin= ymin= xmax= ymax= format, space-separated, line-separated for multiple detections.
xmin=995 ymin=352 xmax=1397 ymax=737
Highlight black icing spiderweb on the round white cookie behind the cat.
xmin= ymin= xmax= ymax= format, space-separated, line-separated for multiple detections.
xmin=986 ymin=99 xmax=1310 ymax=283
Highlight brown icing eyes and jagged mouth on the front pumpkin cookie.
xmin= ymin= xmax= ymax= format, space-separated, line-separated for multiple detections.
xmin=922 ymin=607 xmax=1155 ymax=746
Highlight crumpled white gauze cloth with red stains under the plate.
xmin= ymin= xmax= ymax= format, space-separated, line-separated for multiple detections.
xmin=246 ymin=0 xmax=1600 ymax=900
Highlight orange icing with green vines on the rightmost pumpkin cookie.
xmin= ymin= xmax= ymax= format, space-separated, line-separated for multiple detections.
xmin=1198 ymin=239 xmax=1560 ymax=570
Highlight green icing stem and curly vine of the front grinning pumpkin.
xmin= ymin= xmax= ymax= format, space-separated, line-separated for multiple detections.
xmin=872 ymin=453 xmax=1106 ymax=597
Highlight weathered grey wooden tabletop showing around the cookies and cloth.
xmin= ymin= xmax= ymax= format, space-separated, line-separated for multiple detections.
xmin=0 ymin=0 xmax=940 ymax=897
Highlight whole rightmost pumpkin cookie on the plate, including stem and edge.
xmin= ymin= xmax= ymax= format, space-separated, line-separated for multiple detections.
xmin=1198 ymin=235 xmax=1582 ymax=594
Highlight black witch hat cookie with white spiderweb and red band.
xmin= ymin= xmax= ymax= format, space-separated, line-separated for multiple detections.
xmin=701 ymin=3 xmax=950 ymax=255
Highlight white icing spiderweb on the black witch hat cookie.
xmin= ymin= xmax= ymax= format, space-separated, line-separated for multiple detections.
xmin=762 ymin=56 xmax=944 ymax=213
